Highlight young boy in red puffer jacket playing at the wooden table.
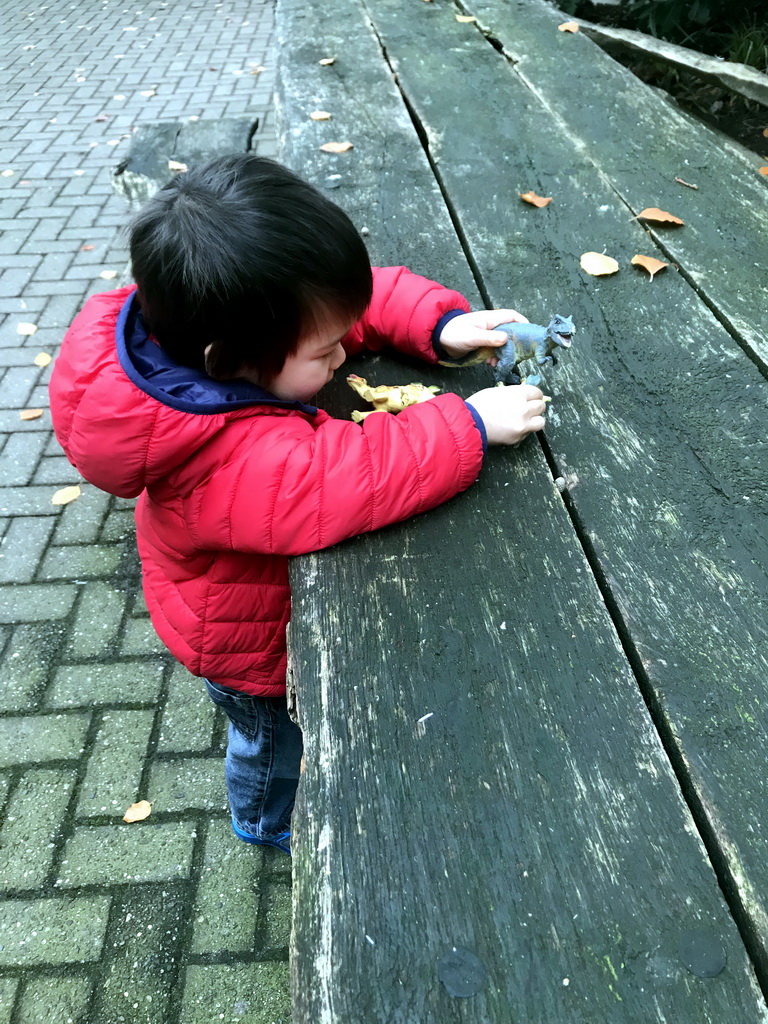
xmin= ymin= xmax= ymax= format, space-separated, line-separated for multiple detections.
xmin=50 ymin=156 xmax=546 ymax=853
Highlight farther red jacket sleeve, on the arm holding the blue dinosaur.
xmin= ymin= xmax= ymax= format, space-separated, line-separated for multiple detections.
xmin=344 ymin=266 xmax=469 ymax=362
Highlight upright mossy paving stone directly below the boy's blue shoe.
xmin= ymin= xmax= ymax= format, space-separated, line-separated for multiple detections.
xmin=191 ymin=821 xmax=264 ymax=953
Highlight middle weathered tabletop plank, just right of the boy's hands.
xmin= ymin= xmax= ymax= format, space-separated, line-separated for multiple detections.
xmin=360 ymin=0 xmax=768 ymax=958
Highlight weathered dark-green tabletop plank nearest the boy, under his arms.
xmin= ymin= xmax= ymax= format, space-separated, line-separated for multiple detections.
xmin=278 ymin=0 xmax=768 ymax=1024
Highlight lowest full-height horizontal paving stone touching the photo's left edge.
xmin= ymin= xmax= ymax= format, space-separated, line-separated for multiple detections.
xmin=0 ymin=896 xmax=110 ymax=967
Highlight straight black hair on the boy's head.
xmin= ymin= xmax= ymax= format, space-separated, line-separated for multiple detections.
xmin=130 ymin=155 xmax=372 ymax=380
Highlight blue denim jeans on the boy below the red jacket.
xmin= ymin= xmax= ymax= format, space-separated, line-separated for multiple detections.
xmin=203 ymin=679 xmax=303 ymax=839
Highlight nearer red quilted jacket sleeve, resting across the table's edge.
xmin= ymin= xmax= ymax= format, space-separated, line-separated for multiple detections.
xmin=181 ymin=394 xmax=482 ymax=555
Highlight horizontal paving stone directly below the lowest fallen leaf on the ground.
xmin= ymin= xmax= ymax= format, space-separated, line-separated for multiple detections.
xmin=55 ymin=821 xmax=197 ymax=888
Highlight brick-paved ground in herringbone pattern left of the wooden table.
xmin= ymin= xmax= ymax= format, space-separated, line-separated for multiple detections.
xmin=0 ymin=0 xmax=290 ymax=1024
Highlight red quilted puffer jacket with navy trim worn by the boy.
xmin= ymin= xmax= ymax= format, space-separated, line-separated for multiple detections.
xmin=50 ymin=267 xmax=482 ymax=696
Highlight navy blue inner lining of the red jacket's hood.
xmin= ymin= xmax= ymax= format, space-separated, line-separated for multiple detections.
xmin=116 ymin=292 xmax=317 ymax=416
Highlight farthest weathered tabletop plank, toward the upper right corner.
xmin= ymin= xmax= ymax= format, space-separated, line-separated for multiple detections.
xmin=468 ymin=0 xmax=768 ymax=371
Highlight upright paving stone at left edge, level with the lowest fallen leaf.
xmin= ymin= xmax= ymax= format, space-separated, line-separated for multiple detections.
xmin=0 ymin=768 xmax=75 ymax=890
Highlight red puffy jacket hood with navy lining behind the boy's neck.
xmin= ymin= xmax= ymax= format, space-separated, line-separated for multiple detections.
xmin=50 ymin=288 xmax=317 ymax=498
